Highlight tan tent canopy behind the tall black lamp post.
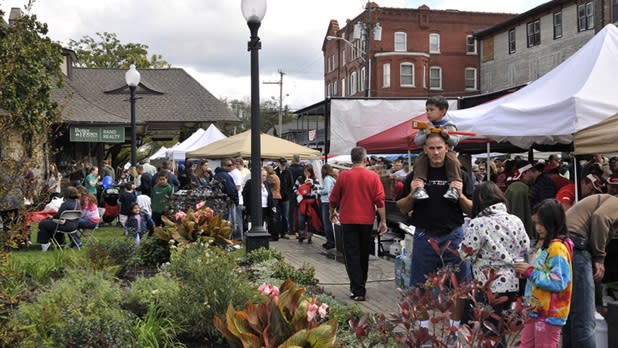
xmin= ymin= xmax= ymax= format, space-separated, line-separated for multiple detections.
xmin=187 ymin=130 xmax=321 ymax=159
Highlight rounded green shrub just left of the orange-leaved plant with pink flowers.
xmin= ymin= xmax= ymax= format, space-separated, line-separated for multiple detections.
xmin=161 ymin=243 xmax=257 ymax=339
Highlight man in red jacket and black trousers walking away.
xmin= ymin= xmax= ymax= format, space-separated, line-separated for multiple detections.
xmin=329 ymin=147 xmax=387 ymax=301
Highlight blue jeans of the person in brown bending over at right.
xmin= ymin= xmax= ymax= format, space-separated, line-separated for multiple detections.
xmin=562 ymin=249 xmax=596 ymax=348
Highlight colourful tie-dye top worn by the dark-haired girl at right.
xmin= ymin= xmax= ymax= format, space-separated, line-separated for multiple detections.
xmin=525 ymin=239 xmax=573 ymax=326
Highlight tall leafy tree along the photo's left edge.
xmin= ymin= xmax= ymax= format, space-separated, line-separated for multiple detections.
xmin=0 ymin=2 xmax=63 ymax=248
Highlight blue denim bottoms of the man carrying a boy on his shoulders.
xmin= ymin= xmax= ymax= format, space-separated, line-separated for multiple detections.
xmin=410 ymin=226 xmax=472 ymax=286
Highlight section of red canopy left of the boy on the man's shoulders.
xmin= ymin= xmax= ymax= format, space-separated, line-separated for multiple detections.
xmin=356 ymin=113 xmax=427 ymax=153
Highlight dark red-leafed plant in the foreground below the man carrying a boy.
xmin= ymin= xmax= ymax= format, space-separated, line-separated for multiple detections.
xmin=349 ymin=235 xmax=529 ymax=348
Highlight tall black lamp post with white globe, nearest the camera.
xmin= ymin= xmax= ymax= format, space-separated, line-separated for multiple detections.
xmin=240 ymin=0 xmax=270 ymax=252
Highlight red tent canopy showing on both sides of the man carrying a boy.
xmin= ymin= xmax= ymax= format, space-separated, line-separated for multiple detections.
xmin=356 ymin=113 xmax=502 ymax=154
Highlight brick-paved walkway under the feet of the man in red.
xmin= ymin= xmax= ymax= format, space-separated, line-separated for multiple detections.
xmin=269 ymin=235 xmax=400 ymax=314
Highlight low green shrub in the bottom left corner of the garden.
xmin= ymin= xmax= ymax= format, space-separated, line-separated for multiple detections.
xmin=6 ymin=270 xmax=134 ymax=347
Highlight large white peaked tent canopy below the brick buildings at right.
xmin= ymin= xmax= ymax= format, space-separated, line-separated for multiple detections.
xmin=449 ymin=24 xmax=618 ymax=148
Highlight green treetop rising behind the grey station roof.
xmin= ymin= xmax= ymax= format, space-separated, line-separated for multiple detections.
xmin=69 ymin=32 xmax=171 ymax=69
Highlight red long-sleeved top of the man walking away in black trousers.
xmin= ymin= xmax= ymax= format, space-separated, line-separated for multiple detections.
xmin=329 ymin=167 xmax=384 ymax=225
